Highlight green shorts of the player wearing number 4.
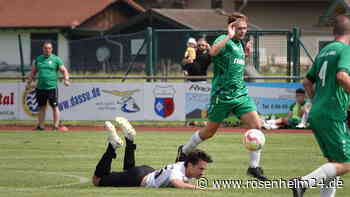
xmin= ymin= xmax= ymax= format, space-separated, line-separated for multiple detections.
xmin=309 ymin=117 xmax=350 ymax=163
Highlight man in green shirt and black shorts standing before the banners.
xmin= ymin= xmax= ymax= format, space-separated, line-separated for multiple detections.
xmin=28 ymin=42 xmax=70 ymax=131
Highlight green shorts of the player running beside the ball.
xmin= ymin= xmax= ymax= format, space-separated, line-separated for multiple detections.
xmin=208 ymin=96 xmax=256 ymax=123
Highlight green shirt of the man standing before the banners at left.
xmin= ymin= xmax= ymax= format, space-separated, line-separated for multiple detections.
xmin=34 ymin=54 xmax=63 ymax=90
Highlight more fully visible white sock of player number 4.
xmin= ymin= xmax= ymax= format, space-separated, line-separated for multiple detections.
xmin=301 ymin=163 xmax=337 ymax=188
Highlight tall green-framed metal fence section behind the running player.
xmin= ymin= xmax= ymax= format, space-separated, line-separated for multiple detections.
xmin=150 ymin=29 xmax=300 ymax=81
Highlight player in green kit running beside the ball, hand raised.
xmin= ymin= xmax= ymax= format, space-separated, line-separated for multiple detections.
xmin=176 ymin=12 xmax=267 ymax=180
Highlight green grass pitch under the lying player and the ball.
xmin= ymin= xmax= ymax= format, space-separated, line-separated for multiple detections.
xmin=0 ymin=131 xmax=350 ymax=197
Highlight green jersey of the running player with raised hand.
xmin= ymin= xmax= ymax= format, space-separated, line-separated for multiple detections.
xmin=211 ymin=34 xmax=248 ymax=103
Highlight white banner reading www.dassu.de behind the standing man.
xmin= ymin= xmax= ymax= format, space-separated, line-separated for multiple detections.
xmin=21 ymin=83 xmax=144 ymax=120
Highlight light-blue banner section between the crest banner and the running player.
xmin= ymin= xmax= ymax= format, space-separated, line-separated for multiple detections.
xmin=185 ymin=83 xmax=211 ymax=119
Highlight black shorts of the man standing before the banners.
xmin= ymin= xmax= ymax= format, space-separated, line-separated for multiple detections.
xmin=36 ymin=88 xmax=58 ymax=107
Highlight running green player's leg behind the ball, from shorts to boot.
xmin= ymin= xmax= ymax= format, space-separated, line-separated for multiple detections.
xmin=238 ymin=97 xmax=267 ymax=180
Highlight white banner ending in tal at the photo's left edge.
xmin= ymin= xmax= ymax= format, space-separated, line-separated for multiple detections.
xmin=0 ymin=83 xmax=19 ymax=120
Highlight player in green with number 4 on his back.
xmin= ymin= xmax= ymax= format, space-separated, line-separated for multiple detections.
xmin=292 ymin=15 xmax=350 ymax=197
